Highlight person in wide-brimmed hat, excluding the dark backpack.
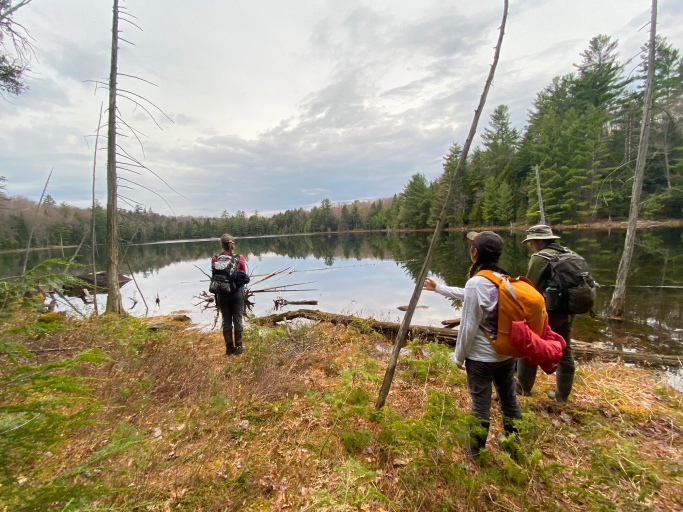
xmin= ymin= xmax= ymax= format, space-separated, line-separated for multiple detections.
xmin=516 ymin=224 xmax=576 ymax=402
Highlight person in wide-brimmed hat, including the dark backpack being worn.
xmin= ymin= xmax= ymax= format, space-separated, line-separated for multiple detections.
xmin=516 ymin=224 xmax=595 ymax=402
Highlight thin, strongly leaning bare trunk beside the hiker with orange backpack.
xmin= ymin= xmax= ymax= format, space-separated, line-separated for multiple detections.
xmin=375 ymin=0 xmax=508 ymax=409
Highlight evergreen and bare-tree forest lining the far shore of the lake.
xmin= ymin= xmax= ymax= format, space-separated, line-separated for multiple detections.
xmin=0 ymin=35 xmax=683 ymax=249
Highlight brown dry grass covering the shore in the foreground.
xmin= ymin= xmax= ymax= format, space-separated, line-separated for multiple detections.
xmin=3 ymin=312 xmax=683 ymax=511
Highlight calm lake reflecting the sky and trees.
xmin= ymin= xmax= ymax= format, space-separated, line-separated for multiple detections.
xmin=0 ymin=228 xmax=683 ymax=354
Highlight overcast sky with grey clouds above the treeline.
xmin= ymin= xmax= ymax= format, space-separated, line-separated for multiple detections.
xmin=0 ymin=0 xmax=683 ymax=215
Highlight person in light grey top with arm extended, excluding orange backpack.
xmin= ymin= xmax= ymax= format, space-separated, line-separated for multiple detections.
xmin=423 ymin=231 xmax=522 ymax=459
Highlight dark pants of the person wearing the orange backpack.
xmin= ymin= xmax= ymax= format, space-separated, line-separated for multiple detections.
xmin=465 ymin=359 xmax=522 ymax=422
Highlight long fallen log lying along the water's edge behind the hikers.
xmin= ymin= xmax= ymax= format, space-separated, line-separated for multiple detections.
xmin=259 ymin=309 xmax=683 ymax=367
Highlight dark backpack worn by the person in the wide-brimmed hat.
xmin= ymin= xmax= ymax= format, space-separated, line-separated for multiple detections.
xmin=534 ymin=247 xmax=597 ymax=315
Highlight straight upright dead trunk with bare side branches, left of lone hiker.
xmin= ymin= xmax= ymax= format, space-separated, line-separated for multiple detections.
xmin=105 ymin=0 xmax=121 ymax=314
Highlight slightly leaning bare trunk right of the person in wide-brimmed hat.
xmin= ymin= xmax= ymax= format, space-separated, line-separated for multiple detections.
xmin=610 ymin=0 xmax=657 ymax=317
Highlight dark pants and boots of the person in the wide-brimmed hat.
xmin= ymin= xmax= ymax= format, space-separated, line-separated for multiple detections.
xmin=517 ymin=315 xmax=576 ymax=400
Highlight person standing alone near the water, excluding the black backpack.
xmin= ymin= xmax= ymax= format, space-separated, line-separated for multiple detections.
xmin=211 ymin=233 xmax=247 ymax=356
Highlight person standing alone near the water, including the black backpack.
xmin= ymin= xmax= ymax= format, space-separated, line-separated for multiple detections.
xmin=214 ymin=234 xmax=247 ymax=356
